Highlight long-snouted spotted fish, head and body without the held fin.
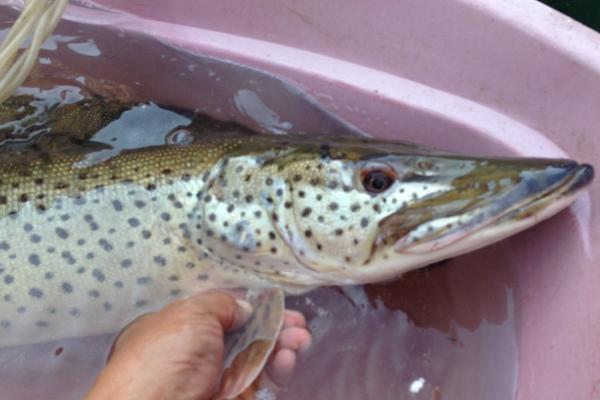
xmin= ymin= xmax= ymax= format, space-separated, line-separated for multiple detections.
xmin=0 ymin=133 xmax=593 ymax=346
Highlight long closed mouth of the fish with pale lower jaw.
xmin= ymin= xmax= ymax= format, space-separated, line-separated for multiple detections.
xmin=376 ymin=160 xmax=594 ymax=254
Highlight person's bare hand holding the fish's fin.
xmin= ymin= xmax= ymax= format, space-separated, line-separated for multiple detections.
xmin=86 ymin=292 xmax=311 ymax=400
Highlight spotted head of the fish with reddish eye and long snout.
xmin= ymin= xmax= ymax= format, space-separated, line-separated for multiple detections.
xmin=199 ymin=139 xmax=593 ymax=284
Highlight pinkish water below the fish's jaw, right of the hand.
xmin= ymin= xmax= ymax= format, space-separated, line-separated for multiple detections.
xmin=280 ymin=243 xmax=518 ymax=400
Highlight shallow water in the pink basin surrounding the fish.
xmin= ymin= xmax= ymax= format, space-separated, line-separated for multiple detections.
xmin=0 ymin=7 xmax=518 ymax=400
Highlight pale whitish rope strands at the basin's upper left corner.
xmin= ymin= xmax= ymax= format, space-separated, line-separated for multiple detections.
xmin=0 ymin=0 xmax=69 ymax=103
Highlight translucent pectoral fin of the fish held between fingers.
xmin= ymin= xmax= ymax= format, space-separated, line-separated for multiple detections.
xmin=215 ymin=289 xmax=285 ymax=400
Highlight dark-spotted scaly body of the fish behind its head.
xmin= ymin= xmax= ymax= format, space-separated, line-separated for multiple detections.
xmin=0 ymin=135 xmax=278 ymax=345
